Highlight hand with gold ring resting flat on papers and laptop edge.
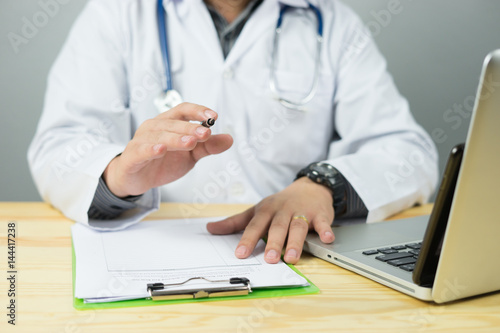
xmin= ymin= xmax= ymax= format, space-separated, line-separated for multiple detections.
xmin=207 ymin=177 xmax=335 ymax=264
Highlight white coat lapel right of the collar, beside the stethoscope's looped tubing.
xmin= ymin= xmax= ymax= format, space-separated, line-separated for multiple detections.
xmin=226 ymin=0 xmax=280 ymax=66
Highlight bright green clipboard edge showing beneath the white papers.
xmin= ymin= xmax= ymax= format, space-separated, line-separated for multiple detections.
xmin=71 ymin=242 xmax=319 ymax=310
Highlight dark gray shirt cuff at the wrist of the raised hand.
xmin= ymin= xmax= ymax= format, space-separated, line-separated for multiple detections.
xmin=87 ymin=177 xmax=142 ymax=220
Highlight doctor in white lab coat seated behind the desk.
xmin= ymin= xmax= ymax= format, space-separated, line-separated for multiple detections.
xmin=28 ymin=0 xmax=437 ymax=263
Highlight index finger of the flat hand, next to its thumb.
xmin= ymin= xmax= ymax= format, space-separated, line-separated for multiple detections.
xmin=235 ymin=212 xmax=272 ymax=259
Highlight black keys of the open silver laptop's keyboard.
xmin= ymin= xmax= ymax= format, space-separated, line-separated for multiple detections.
xmin=362 ymin=242 xmax=422 ymax=272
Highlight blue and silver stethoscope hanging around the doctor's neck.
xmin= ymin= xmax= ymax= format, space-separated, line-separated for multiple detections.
xmin=155 ymin=0 xmax=323 ymax=113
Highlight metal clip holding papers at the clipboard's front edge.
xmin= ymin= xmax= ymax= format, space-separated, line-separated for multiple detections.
xmin=148 ymin=276 xmax=252 ymax=301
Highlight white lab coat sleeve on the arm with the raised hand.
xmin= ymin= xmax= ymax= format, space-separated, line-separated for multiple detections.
xmin=28 ymin=0 xmax=160 ymax=230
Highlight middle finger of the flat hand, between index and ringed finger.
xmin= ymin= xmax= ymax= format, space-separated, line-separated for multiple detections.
xmin=264 ymin=211 xmax=291 ymax=264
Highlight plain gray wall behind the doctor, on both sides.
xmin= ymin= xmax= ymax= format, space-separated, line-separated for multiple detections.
xmin=0 ymin=0 xmax=500 ymax=201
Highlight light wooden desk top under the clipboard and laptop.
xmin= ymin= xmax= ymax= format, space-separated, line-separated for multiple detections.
xmin=0 ymin=203 xmax=500 ymax=333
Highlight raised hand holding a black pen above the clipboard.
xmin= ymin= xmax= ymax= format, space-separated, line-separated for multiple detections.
xmin=103 ymin=103 xmax=233 ymax=197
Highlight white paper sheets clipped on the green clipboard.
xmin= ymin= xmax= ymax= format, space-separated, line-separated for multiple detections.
xmin=72 ymin=218 xmax=308 ymax=302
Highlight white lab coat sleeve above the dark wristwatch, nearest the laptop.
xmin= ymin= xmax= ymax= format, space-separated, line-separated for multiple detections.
xmin=327 ymin=6 xmax=438 ymax=222
